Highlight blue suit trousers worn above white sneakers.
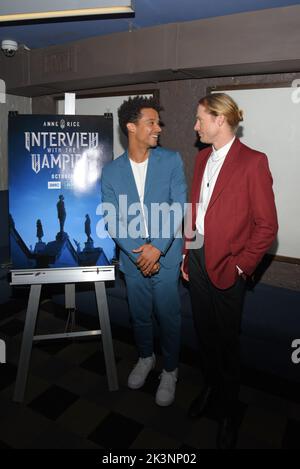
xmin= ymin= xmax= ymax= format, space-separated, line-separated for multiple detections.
xmin=125 ymin=265 xmax=181 ymax=371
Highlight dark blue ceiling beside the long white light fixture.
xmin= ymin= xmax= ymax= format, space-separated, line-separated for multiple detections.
xmin=0 ymin=0 xmax=300 ymax=49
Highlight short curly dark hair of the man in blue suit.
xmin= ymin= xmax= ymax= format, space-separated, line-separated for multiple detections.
xmin=118 ymin=96 xmax=162 ymax=135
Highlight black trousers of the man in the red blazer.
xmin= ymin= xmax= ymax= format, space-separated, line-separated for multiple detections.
xmin=189 ymin=247 xmax=245 ymax=415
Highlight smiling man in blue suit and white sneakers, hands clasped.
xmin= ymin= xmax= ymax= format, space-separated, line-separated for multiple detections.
xmin=101 ymin=97 xmax=186 ymax=406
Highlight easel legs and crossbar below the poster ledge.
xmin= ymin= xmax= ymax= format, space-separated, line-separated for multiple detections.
xmin=13 ymin=281 xmax=118 ymax=402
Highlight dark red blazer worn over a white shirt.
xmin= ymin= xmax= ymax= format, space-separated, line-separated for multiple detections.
xmin=184 ymin=138 xmax=278 ymax=289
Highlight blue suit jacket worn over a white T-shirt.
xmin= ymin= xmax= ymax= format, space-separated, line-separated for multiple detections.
xmin=101 ymin=147 xmax=186 ymax=276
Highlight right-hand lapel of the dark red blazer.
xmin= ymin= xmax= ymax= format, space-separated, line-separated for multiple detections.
xmin=207 ymin=138 xmax=241 ymax=211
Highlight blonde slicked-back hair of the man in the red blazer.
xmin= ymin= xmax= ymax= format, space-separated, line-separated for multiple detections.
xmin=199 ymin=93 xmax=243 ymax=131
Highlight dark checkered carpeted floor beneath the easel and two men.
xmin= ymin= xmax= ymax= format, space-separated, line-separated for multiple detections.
xmin=0 ymin=288 xmax=300 ymax=451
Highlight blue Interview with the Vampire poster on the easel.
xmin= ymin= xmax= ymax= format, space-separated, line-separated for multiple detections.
xmin=8 ymin=115 xmax=115 ymax=269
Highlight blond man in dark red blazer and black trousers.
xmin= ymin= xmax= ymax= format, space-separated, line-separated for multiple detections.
xmin=182 ymin=93 xmax=278 ymax=448
